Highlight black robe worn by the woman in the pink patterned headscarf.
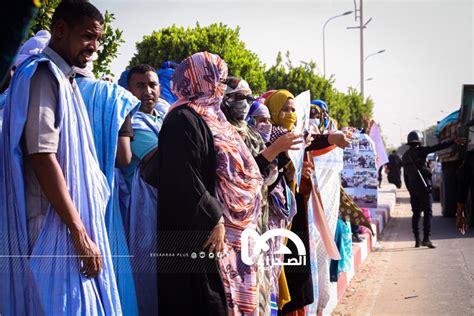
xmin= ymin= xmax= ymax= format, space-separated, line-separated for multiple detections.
xmin=157 ymin=105 xmax=226 ymax=316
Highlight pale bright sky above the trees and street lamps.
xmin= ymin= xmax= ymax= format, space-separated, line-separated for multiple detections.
xmin=91 ymin=0 xmax=474 ymax=146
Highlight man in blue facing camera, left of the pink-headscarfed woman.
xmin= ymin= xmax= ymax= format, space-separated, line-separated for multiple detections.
xmin=125 ymin=65 xmax=163 ymax=315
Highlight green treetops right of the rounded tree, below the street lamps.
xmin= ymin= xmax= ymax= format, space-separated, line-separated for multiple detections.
xmin=265 ymin=52 xmax=373 ymax=127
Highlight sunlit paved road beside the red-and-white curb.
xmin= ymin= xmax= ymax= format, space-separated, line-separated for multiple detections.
xmin=333 ymin=189 xmax=474 ymax=315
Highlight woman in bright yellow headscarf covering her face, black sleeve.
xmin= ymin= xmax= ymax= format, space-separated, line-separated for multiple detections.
xmin=265 ymin=89 xmax=344 ymax=315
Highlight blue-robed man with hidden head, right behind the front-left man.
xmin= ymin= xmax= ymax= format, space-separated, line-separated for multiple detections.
xmin=75 ymin=65 xmax=140 ymax=315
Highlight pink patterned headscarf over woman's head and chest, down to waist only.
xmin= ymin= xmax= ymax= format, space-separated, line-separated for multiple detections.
xmin=173 ymin=52 xmax=262 ymax=228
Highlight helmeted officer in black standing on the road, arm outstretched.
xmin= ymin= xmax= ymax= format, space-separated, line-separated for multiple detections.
xmin=402 ymin=130 xmax=454 ymax=248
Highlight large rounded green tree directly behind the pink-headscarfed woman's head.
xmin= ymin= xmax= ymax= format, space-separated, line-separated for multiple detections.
xmin=129 ymin=23 xmax=266 ymax=93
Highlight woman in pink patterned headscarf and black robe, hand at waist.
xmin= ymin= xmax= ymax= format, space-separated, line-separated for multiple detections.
xmin=157 ymin=52 xmax=263 ymax=315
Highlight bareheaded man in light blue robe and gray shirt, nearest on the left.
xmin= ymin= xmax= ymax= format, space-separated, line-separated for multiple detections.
xmin=0 ymin=1 xmax=122 ymax=315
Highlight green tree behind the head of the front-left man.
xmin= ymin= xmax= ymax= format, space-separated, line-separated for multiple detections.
xmin=28 ymin=0 xmax=124 ymax=78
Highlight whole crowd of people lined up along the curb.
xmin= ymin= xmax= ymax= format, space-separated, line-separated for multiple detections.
xmin=0 ymin=1 xmax=378 ymax=315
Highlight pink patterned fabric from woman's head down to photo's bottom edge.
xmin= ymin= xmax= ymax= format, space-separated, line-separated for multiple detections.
xmin=170 ymin=52 xmax=263 ymax=315
